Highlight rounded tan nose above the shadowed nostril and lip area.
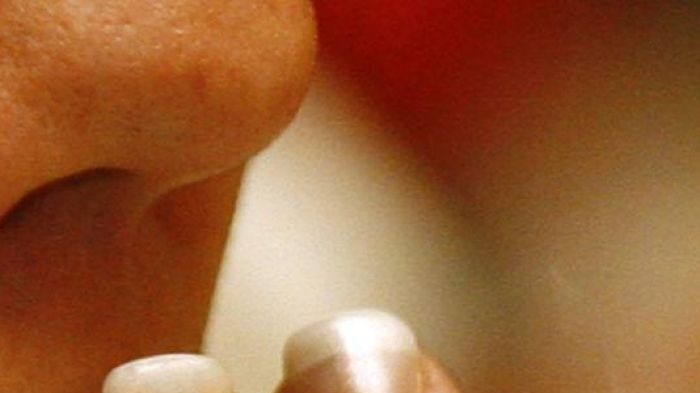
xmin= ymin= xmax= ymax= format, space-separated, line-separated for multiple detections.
xmin=0 ymin=0 xmax=314 ymax=215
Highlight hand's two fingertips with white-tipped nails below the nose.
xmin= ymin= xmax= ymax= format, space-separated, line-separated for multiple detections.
xmin=103 ymin=310 xmax=460 ymax=393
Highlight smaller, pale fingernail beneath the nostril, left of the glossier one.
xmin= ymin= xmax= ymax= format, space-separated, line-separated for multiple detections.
xmin=102 ymin=354 xmax=232 ymax=393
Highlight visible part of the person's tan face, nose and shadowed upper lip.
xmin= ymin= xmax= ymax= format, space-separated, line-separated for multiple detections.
xmin=0 ymin=0 xmax=315 ymax=393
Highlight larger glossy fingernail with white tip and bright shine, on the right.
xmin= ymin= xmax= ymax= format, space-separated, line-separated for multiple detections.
xmin=282 ymin=310 xmax=420 ymax=393
